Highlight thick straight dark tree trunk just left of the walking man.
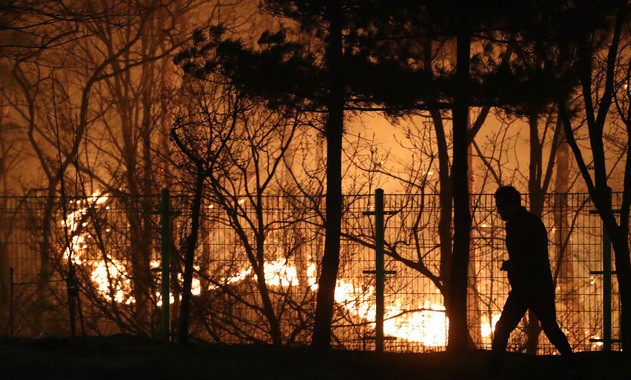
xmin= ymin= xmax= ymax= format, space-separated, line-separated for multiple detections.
xmin=447 ymin=14 xmax=471 ymax=352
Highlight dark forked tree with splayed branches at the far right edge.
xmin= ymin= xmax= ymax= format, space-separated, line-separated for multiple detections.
xmin=558 ymin=1 xmax=631 ymax=348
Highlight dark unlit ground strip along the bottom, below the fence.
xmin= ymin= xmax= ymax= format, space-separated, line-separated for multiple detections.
xmin=0 ymin=337 xmax=631 ymax=380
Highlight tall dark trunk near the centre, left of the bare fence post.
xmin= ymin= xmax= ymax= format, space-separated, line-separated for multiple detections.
xmin=312 ymin=0 xmax=344 ymax=349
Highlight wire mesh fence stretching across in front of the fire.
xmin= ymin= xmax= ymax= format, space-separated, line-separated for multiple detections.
xmin=0 ymin=194 xmax=620 ymax=353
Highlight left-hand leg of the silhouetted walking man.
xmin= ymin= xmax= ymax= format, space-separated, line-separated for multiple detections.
xmin=489 ymin=292 xmax=527 ymax=374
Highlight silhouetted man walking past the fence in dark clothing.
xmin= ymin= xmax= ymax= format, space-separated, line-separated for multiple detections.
xmin=489 ymin=186 xmax=572 ymax=374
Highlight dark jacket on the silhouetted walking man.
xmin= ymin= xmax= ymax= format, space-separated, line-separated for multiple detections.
xmin=506 ymin=207 xmax=554 ymax=295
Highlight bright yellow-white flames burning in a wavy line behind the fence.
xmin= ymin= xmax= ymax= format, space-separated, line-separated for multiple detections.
xmin=62 ymin=194 xmax=454 ymax=347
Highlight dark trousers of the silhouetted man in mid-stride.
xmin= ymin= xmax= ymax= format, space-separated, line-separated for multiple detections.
xmin=490 ymin=291 xmax=572 ymax=369
